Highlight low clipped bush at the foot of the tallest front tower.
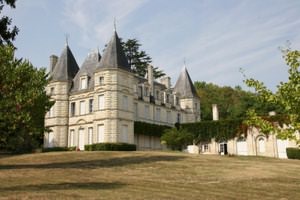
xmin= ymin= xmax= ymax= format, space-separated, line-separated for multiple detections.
xmin=84 ymin=143 xmax=136 ymax=151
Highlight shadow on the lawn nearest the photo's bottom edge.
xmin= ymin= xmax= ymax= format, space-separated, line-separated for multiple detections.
xmin=0 ymin=182 xmax=126 ymax=192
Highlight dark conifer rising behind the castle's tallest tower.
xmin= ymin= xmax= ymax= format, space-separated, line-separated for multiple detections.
xmin=121 ymin=39 xmax=165 ymax=78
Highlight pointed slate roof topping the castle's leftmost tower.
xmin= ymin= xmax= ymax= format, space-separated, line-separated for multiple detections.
xmin=51 ymin=45 xmax=79 ymax=81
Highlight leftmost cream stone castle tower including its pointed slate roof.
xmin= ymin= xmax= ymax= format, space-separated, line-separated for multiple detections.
xmin=44 ymin=45 xmax=79 ymax=147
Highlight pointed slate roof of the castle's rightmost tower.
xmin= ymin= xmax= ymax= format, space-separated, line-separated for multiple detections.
xmin=173 ymin=67 xmax=199 ymax=98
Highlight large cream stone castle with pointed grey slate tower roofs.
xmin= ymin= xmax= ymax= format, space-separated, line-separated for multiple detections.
xmin=44 ymin=31 xmax=200 ymax=150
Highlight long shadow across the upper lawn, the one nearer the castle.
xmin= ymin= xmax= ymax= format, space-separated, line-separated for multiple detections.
xmin=0 ymin=156 xmax=184 ymax=170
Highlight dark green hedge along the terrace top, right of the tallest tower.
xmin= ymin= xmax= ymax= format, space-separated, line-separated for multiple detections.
xmin=134 ymin=121 xmax=172 ymax=137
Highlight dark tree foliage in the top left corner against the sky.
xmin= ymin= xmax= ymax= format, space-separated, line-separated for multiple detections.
xmin=0 ymin=0 xmax=19 ymax=45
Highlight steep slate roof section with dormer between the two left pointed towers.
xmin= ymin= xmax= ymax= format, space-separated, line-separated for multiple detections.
xmin=71 ymin=51 xmax=101 ymax=92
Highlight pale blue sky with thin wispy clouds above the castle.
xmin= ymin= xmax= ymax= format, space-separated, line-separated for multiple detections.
xmin=3 ymin=0 xmax=300 ymax=91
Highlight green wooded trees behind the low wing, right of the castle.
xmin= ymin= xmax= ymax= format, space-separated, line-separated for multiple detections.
xmin=194 ymin=81 xmax=281 ymax=120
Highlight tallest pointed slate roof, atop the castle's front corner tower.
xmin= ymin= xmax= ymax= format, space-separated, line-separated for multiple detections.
xmin=97 ymin=31 xmax=131 ymax=71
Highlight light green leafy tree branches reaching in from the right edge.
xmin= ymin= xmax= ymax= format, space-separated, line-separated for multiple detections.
xmin=245 ymin=49 xmax=300 ymax=144
